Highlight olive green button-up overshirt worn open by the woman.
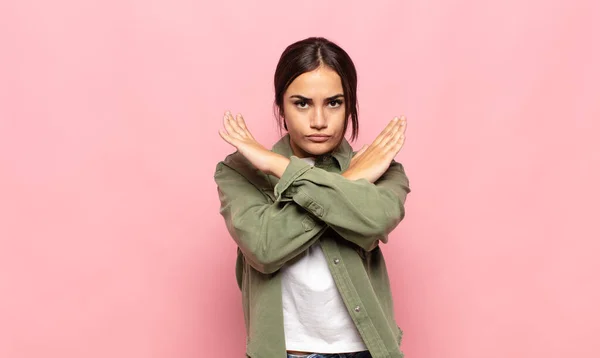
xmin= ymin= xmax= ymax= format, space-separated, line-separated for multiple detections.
xmin=214 ymin=134 xmax=410 ymax=358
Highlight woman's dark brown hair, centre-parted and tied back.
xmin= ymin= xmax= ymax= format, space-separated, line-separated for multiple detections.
xmin=274 ymin=37 xmax=358 ymax=140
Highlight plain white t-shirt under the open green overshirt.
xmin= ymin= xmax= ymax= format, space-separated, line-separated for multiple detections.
xmin=281 ymin=158 xmax=367 ymax=353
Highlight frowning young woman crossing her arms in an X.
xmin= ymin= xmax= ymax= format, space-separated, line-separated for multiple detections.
xmin=214 ymin=38 xmax=410 ymax=358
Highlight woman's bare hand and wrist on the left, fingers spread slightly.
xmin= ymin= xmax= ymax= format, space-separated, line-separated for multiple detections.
xmin=219 ymin=111 xmax=289 ymax=176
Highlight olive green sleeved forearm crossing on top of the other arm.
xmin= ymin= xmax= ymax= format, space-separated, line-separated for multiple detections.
xmin=275 ymin=159 xmax=408 ymax=250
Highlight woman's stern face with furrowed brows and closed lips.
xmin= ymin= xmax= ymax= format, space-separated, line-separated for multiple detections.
xmin=283 ymin=66 xmax=346 ymax=158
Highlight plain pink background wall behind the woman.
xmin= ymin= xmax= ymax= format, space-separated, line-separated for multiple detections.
xmin=0 ymin=0 xmax=600 ymax=358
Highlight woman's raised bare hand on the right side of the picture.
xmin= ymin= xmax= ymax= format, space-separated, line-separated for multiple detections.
xmin=342 ymin=116 xmax=406 ymax=183
